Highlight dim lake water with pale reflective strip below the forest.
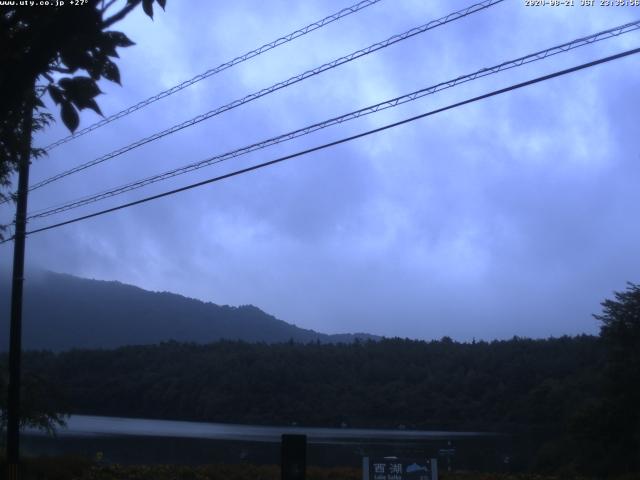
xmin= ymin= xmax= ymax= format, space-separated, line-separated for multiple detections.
xmin=22 ymin=415 xmax=513 ymax=469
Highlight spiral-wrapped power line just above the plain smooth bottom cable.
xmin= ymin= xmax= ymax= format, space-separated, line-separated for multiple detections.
xmin=28 ymin=20 xmax=640 ymax=219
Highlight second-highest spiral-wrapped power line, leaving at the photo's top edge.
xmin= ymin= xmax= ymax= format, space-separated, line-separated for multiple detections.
xmin=25 ymin=0 xmax=504 ymax=195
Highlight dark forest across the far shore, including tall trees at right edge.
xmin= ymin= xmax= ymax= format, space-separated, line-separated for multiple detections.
xmin=0 ymin=284 xmax=640 ymax=474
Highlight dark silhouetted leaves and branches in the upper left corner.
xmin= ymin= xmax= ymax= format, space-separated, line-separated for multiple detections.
xmin=0 ymin=0 xmax=166 ymax=207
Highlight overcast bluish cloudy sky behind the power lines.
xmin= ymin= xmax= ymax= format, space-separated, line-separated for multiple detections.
xmin=0 ymin=0 xmax=640 ymax=340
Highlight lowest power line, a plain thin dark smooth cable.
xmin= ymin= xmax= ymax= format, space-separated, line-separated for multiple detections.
xmin=7 ymin=48 xmax=640 ymax=243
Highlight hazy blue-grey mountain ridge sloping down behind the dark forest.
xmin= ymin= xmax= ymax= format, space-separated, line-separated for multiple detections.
xmin=0 ymin=271 xmax=380 ymax=351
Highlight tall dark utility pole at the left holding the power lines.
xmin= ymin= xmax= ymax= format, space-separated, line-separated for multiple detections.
xmin=7 ymin=81 xmax=35 ymax=480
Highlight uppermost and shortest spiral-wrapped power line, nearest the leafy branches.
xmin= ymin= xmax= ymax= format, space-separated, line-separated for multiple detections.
xmin=44 ymin=0 xmax=381 ymax=151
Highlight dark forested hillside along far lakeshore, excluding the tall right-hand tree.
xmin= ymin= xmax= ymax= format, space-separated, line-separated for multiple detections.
xmin=18 ymin=336 xmax=603 ymax=431
